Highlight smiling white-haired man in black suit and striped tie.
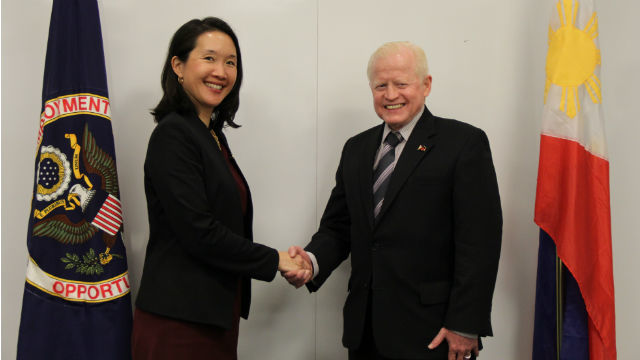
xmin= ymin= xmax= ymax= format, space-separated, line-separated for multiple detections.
xmin=283 ymin=42 xmax=502 ymax=360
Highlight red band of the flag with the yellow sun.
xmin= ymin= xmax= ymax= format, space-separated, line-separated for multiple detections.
xmin=535 ymin=135 xmax=616 ymax=360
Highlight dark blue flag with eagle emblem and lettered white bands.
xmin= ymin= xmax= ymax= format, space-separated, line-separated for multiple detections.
xmin=17 ymin=0 xmax=131 ymax=360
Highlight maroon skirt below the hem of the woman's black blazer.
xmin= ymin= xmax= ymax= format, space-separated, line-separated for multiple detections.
xmin=131 ymin=299 xmax=240 ymax=360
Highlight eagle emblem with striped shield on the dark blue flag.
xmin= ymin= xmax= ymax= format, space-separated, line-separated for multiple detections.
xmin=33 ymin=123 xmax=122 ymax=275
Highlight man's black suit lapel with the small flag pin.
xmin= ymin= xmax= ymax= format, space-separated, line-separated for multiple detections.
xmin=378 ymin=107 xmax=436 ymax=223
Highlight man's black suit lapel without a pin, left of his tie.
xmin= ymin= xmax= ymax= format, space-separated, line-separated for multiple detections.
xmin=358 ymin=124 xmax=384 ymax=228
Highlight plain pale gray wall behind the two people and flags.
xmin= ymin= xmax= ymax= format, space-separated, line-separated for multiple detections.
xmin=2 ymin=0 xmax=640 ymax=360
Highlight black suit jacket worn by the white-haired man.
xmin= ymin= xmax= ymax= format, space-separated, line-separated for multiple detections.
xmin=305 ymin=107 xmax=502 ymax=359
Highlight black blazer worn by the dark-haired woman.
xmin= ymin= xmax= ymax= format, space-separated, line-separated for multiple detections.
xmin=136 ymin=113 xmax=278 ymax=328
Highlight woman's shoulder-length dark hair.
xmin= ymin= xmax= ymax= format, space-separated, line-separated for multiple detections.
xmin=151 ymin=17 xmax=242 ymax=130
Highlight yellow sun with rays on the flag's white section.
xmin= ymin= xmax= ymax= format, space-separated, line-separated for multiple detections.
xmin=544 ymin=0 xmax=602 ymax=118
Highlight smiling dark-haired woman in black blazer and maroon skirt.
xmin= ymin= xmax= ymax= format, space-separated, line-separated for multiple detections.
xmin=132 ymin=17 xmax=302 ymax=360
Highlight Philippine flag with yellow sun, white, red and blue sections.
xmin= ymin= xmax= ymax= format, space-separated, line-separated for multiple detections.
xmin=533 ymin=0 xmax=616 ymax=360
